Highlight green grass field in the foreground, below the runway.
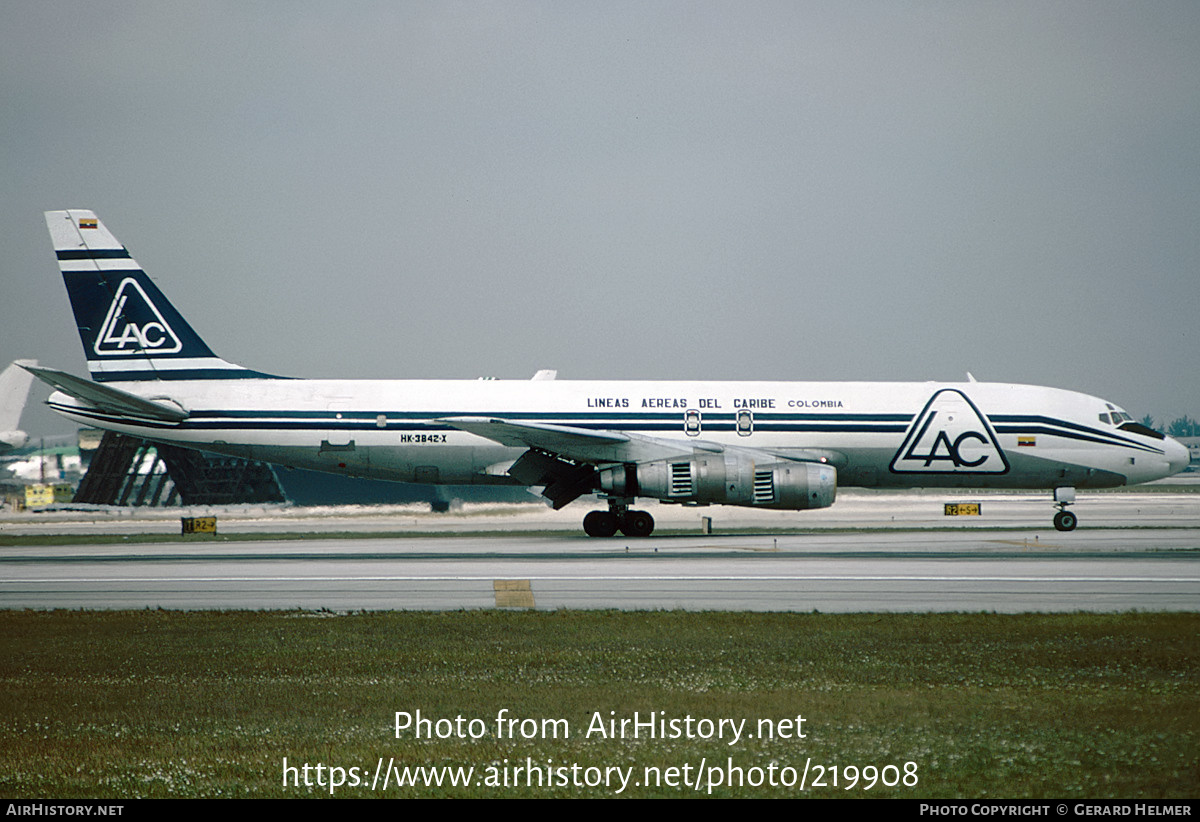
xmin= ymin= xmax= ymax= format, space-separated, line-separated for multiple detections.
xmin=0 ymin=611 xmax=1200 ymax=798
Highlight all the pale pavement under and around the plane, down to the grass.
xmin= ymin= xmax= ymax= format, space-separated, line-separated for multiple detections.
xmin=0 ymin=492 xmax=1200 ymax=612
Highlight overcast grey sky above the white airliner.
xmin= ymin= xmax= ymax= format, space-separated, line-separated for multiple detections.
xmin=0 ymin=0 xmax=1200 ymax=433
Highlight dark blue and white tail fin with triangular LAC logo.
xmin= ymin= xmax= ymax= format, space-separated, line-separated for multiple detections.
xmin=46 ymin=209 xmax=277 ymax=382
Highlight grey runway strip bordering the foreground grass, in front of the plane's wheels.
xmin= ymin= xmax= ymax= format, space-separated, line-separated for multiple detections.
xmin=0 ymin=528 xmax=1200 ymax=612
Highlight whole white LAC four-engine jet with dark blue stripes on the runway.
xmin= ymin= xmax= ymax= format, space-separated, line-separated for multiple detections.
xmin=29 ymin=210 xmax=1188 ymax=536
